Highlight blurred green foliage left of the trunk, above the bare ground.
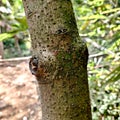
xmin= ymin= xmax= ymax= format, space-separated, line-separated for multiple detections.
xmin=0 ymin=0 xmax=30 ymax=58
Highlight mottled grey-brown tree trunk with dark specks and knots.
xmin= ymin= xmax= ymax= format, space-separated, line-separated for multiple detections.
xmin=23 ymin=0 xmax=91 ymax=120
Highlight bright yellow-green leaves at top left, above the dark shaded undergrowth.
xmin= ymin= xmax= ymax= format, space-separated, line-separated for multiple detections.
xmin=0 ymin=0 xmax=28 ymax=41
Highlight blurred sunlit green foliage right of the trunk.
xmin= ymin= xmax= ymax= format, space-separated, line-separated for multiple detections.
xmin=73 ymin=0 xmax=120 ymax=120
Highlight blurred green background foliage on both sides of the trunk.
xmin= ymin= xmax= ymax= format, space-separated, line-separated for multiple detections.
xmin=0 ymin=0 xmax=120 ymax=120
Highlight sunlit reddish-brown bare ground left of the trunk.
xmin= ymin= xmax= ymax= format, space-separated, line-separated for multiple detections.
xmin=0 ymin=58 xmax=41 ymax=120
